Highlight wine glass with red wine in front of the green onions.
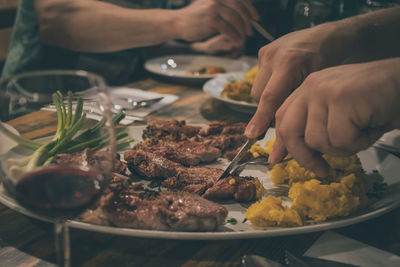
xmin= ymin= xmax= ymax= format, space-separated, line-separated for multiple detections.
xmin=0 ymin=70 xmax=116 ymax=266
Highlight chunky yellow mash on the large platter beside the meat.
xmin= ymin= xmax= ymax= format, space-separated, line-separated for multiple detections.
xmin=246 ymin=140 xmax=372 ymax=227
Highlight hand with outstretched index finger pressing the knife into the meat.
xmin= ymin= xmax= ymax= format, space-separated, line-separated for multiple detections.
xmin=245 ymin=22 xmax=355 ymax=138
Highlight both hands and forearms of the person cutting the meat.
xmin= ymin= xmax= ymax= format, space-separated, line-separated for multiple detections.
xmin=246 ymin=6 xmax=400 ymax=177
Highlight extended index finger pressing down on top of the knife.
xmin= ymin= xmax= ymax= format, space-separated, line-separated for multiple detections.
xmin=245 ymin=71 xmax=295 ymax=138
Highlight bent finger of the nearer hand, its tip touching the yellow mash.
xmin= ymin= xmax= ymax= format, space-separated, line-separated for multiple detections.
xmin=278 ymin=99 xmax=328 ymax=177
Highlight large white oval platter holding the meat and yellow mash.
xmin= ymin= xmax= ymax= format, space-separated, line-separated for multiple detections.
xmin=0 ymin=127 xmax=400 ymax=240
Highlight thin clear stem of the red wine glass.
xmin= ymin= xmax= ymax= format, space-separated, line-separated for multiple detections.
xmin=54 ymin=219 xmax=71 ymax=267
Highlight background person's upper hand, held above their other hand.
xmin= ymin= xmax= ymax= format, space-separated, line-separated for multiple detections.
xmin=176 ymin=0 xmax=259 ymax=45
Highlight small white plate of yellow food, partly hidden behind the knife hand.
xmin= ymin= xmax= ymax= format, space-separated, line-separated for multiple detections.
xmin=203 ymin=72 xmax=257 ymax=114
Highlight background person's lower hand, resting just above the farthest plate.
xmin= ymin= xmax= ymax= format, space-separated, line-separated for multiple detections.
xmin=191 ymin=34 xmax=244 ymax=58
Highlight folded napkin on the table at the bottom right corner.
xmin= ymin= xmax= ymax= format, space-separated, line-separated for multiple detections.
xmin=304 ymin=231 xmax=400 ymax=267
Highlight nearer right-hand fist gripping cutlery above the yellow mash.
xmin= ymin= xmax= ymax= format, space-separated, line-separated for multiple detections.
xmin=269 ymin=58 xmax=400 ymax=177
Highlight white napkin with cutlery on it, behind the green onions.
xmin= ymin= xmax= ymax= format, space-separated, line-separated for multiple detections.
xmin=43 ymin=87 xmax=178 ymax=125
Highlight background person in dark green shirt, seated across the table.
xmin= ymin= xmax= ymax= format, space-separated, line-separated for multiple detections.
xmin=1 ymin=0 xmax=259 ymax=84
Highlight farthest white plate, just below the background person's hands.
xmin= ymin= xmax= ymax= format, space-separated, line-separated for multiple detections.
xmin=144 ymin=55 xmax=256 ymax=82
